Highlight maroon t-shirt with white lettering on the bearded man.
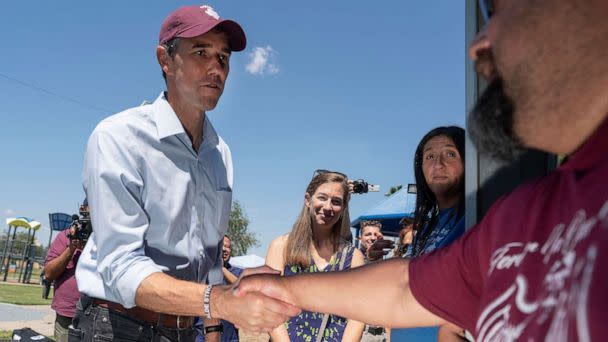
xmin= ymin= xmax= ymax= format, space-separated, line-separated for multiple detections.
xmin=409 ymin=120 xmax=608 ymax=341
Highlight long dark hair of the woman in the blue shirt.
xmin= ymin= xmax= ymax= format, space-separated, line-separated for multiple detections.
xmin=412 ymin=126 xmax=465 ymax=256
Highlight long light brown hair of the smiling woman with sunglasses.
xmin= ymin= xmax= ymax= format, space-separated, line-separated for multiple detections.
xmin=285 ymin=172 xmax=351 ymax=267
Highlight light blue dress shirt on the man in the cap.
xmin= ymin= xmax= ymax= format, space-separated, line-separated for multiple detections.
xmin=76 ymin=93 xmax=232 ymax=308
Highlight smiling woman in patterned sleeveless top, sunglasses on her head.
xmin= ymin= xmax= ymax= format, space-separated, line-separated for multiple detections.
xmin=266 ymin=170 xmax=364 ymax=341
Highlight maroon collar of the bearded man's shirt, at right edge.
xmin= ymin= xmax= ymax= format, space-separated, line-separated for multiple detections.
xmin=560 ymin=118 xmax=608 ymax=170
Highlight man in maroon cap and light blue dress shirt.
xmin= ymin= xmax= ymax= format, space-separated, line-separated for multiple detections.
xmin=69 ymin=6 xmax=299 ymax=341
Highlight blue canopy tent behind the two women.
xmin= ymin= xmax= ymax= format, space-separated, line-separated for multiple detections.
xmin=350 ymin=187 xmax=416 ymax=238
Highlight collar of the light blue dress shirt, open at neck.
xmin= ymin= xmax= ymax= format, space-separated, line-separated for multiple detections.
xmin=152 ymin=91 xmax=219 ymax=147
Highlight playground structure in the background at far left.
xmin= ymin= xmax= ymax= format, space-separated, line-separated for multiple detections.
xmin=0 ymin=217 xmax=45 ymax=283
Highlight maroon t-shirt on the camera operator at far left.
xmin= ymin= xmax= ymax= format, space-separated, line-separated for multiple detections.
xmin=44 ymin=229 xmax=82 ymax=317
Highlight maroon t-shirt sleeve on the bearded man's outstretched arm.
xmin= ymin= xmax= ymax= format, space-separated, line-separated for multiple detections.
xmin=409 ymin=216 xmax=489 ymax=331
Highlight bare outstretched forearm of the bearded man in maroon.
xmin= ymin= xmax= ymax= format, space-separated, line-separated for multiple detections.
xmin=282 ymin=259 xmax=444 ymax=327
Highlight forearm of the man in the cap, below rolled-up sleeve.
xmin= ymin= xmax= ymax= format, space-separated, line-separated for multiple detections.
xmin=135 ymin=272 xmax=206 ymax=317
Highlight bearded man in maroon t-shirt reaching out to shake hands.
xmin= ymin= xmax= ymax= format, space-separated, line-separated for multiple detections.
xmin=237 ymin=0 xmax=608 ymax=341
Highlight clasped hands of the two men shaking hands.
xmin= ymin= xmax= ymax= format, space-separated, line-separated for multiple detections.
xmin=209 ymin=266 xmax=301 ymax=333
